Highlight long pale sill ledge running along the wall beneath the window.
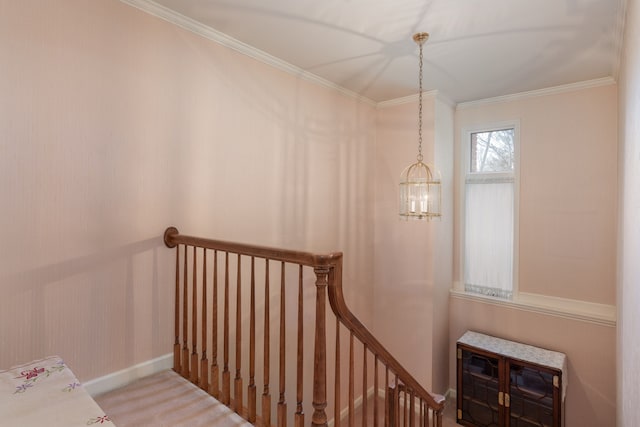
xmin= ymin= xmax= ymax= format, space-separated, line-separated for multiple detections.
xmin=450 ymin=289 xmax=617 ymax=327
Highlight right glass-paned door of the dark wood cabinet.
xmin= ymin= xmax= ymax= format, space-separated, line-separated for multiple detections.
xmin=509 ymin=362 xmax=553 ymax=427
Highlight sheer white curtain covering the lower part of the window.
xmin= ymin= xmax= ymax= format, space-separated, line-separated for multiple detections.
xmin=464 ymin=174 xmax=514 ymax=298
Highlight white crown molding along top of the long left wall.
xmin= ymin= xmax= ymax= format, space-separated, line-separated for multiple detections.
xmin=120 ymin=0 xmax=376 ymax=107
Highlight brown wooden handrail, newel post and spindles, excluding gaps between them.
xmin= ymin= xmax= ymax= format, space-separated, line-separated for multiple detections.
xmin=164 ymin=227 xmax=444 ymax=427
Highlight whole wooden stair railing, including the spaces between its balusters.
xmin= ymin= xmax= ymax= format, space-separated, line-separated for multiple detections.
xmin=164 ymin=227 xmax=444 ymax=427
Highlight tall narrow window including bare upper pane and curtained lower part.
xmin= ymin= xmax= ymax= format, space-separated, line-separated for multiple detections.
xmin=462 ymin=124 xmax=518 ymax=299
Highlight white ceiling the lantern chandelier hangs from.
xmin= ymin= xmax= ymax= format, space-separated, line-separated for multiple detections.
xmin=131 ymin=0 xmax=625 ymax=103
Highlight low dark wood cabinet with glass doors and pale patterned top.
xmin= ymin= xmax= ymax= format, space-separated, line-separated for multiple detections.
xmin=457 ymin=331 xmax=567 ymax=427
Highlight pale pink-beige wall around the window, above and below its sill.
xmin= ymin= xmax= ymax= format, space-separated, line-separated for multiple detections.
xmin=450 ymin=84 xmax=617 ymax=427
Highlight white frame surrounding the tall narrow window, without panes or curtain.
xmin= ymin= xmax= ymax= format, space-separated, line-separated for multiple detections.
xmin=454 ymin=119 xmax=520 ymax=301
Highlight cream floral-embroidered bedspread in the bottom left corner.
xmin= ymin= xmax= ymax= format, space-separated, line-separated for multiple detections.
xmin=0 ymin=356 xmax=114 ymax=427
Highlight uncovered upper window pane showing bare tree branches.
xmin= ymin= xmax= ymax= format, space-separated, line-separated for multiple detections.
xmin=470 ymin=129 xmax=514 ymax=173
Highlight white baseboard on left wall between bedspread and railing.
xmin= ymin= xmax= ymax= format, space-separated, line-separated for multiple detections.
xmin=83 ymin=353 xmax=173 ymax=397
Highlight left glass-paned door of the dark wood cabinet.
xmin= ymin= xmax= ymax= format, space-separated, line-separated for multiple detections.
xmin=457 ymin=346 xmax=504 ymax=427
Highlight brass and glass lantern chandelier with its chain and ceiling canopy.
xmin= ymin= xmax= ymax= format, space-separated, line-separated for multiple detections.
xmin=400 ymin=33 xmax=442 ymax=221
